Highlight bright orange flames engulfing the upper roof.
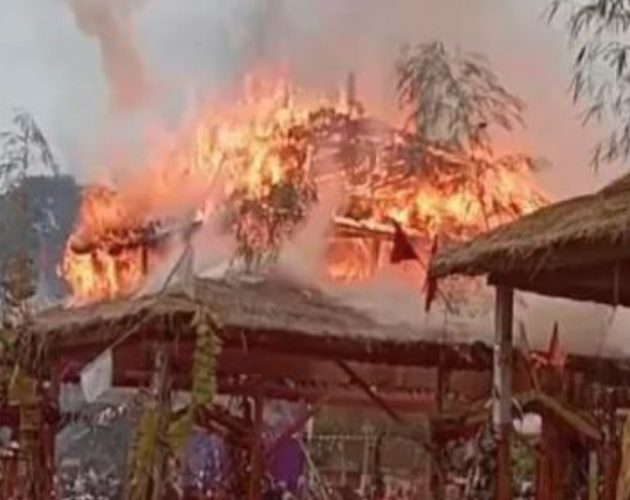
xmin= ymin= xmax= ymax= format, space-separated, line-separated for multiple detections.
xmin=61 ymin=77 xmax=545 ymax=302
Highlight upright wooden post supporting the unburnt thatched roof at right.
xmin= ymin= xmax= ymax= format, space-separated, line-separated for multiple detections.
xmin=492 ymin=286 xmax=514 ymax=500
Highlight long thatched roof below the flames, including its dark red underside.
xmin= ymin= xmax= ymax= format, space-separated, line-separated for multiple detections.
xmin=31 ymin=277 xmax=492 ymax=411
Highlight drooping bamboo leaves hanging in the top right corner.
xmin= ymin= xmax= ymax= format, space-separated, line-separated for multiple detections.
xmin=549 ymin=0 xmax=630 ymax=167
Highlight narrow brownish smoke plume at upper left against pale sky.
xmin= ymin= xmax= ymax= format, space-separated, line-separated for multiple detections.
xmin=68 ymin=0 xmax=150 ymax=109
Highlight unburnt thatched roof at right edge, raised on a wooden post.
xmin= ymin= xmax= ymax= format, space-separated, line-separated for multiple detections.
xmin=430 ymin=175 xmax=630 ymax=305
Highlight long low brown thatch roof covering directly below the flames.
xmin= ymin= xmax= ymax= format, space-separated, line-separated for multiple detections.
xmin=33 ymin=278 xmax=491 ymax=369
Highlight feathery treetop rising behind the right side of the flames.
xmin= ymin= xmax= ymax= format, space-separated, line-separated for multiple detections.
xmin=396 ymin=41 xmax=524 ymax=151
